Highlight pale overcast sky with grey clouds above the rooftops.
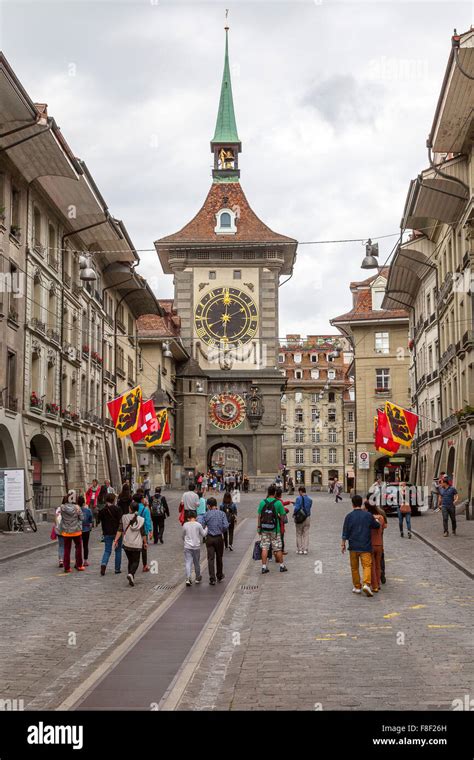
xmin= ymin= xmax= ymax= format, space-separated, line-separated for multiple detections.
xmin=0 ymin=0 xmax=472 ymax=335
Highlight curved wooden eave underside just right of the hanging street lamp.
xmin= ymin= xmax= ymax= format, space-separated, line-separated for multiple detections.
xmin=382 ymin=238 xmax=433 ymax=309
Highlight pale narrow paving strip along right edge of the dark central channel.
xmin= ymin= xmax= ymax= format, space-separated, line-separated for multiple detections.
xmin=158 ymin=517 xmax=255 ymax=712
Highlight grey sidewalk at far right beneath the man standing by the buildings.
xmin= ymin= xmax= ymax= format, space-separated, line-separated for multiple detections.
xmin=411 ymin=509 xmax=474 ymax=578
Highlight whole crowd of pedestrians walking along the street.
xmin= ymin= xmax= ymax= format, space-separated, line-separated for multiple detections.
xmin=51 ymin=466 xmax=458 ymax=596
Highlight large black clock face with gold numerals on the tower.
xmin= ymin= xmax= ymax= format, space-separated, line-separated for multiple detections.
xmin=194 ymin=287 xmax=258 ymax=346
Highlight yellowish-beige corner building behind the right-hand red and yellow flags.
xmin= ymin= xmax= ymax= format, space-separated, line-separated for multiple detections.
xmin=331 ymin=268 xmax=411 ymax=494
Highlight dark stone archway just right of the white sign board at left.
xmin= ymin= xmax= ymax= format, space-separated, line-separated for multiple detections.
xmin=30 ymin=433 xmax=59 ymax=509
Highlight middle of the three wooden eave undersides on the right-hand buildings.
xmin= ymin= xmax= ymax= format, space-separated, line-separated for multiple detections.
xmin=401 ymin=175 xmax=469 ymax=238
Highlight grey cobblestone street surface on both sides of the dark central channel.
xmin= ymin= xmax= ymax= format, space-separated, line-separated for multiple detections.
xmin=0 ymin=494 xmax=474 ymax=710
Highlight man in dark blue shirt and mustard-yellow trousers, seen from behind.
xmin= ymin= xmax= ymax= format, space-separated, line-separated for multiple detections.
xmin=341 ymin=494 xmax=380 ymax=596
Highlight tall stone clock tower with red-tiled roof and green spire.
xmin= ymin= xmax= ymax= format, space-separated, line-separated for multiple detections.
xmin=155 ymin=27 xmax=297 ymax=487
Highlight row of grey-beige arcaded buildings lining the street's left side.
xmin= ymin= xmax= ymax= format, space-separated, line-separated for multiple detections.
xmin=0 ymin=56 xmax=160 ymax=511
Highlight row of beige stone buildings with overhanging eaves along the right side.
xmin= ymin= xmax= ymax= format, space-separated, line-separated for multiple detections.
xmin=384 ymin=30 xmax=474 ymax=516
